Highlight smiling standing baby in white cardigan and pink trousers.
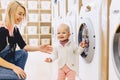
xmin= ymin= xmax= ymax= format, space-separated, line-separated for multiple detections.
xmin=45 ymin=23 xmax=85 ymax=80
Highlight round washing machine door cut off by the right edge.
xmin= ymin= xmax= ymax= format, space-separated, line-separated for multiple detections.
xmin=113 ymin=26 xmax=120 ymax=78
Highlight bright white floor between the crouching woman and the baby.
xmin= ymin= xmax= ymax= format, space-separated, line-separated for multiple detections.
xmin=25 ymin=52 xmax=80 ymax=80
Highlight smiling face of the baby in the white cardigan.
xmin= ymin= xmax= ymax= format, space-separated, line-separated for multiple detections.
xmin=57 ymin=26 xmax=70 ymax=41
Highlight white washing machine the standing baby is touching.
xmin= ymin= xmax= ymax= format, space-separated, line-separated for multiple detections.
xmin=78 ymin=0 xmax=101 ymax=80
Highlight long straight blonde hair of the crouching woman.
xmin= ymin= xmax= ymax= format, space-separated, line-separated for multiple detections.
xmin=5 ymin=0 xmax=26 ymax=29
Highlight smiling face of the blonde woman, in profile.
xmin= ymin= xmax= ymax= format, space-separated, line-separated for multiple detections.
xmin=15 ymin=6 xmax=25 ymax=24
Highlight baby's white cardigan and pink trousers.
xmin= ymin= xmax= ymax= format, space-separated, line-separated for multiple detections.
xmin=52 ymin=41 xmax=84 ymax=80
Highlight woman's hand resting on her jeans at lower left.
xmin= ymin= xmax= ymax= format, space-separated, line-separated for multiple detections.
xmin=12 ymin=66 xmax=26 ymax=79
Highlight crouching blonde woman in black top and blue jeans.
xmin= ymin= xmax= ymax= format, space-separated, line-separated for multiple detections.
xmin=0 ymin=0 xmax=52 ymax=80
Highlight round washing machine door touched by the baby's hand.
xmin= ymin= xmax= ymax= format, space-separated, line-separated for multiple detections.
xmin=78 ymin=19 xmax=95 ymax=63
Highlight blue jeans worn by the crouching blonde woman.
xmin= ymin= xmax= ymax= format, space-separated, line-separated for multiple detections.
xmin=0 ymin=50 xmax=28 ymax=80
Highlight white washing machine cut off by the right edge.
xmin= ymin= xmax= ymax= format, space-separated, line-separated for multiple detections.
xmin=109 ymin=0 xmax=120 ymax=80
